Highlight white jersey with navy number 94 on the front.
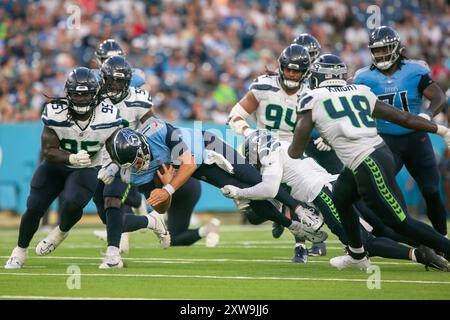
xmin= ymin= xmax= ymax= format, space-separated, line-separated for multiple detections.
xmin=250 ymin=75 xmax=309 ymax=141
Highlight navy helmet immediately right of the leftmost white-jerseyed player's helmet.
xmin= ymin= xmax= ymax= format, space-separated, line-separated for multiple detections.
xmin=100 ymin=56 xmax=132 ymax=103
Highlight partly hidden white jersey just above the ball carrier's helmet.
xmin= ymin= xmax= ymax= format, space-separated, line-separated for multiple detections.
xmin=104 ymin=87 xmax=153 ymax=129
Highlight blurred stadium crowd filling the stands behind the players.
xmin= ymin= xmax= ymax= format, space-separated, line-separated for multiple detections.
xmin=0 ymin=0 xmax=450 ymax=123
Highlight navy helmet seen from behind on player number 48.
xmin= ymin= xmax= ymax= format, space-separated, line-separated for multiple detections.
xmin=309 ymin=54 xmax=347 ymax=89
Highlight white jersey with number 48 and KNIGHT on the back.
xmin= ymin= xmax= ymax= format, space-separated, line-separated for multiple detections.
xmin=297 ymin=84 xmax=383 ymax=170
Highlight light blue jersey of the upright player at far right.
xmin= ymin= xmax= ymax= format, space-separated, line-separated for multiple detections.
xmin=353 ymin=60 xmax=433 ymax=135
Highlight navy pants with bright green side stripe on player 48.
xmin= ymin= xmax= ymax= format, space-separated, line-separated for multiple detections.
xmin=333 ymin=144 xmax=450 ymax=254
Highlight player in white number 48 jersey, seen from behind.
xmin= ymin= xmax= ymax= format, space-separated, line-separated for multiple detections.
xmin=288 ymin=54 xmax=450 ymax=269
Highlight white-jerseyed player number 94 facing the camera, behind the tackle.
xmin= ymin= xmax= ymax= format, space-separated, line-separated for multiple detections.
xmin=228 ymin=44 xmax=325 ymax=252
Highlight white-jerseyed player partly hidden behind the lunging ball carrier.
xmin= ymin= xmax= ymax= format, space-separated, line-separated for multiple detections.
xmin=90 ymin=55 xmax=170 ymax=262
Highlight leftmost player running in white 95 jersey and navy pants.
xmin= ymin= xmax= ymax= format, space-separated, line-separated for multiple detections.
xmin=5 ymin=67 xmax=122 ymax=269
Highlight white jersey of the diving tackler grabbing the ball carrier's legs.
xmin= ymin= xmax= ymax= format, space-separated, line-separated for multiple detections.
xmin=241 ymin=139 xmax=338 ymax=203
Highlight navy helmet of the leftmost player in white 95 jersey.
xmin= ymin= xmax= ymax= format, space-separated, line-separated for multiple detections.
xmin=64 ymin=67 xmax=100 ymax=114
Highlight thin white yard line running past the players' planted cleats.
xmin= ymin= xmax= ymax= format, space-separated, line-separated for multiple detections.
xmin=0 ymin=256 xmax=420 ymax=268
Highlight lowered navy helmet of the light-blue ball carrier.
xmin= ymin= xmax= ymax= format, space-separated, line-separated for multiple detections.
xmin=106 ymin=128 xmax=151 ymax=170
